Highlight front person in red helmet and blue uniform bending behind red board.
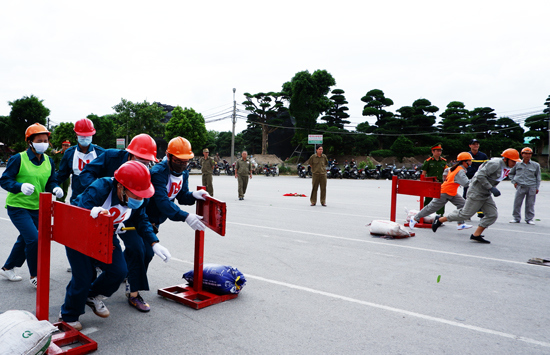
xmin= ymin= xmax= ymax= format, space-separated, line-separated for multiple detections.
xmin=59 ymin=161 xmax=171 ymax=329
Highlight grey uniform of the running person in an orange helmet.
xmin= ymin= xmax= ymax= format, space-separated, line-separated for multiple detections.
xmin=447 ymin=158 xmax=510 ymax=228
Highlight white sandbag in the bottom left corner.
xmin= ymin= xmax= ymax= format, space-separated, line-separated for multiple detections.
xmin=0 ymin=310 xmax=58 ymax=355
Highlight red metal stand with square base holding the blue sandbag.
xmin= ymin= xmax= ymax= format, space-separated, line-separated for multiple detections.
xmin=158 ymin=186 xmax=238 ymax=309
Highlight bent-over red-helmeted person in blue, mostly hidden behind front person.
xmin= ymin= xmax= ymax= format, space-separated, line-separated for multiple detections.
xmin=80 ymin=133 xmax=158 ymax=195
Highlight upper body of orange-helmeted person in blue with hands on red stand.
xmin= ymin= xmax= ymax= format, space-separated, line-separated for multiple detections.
xmin=149 ymin=137 xmax=208 ymax=234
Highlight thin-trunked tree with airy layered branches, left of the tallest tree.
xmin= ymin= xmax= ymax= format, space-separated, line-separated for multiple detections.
xmin=243 ymin=92 xmax=288 ymax=154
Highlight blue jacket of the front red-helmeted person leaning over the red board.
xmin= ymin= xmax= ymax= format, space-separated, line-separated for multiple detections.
xmin=74 ymin=177 xmax=159 ymax=244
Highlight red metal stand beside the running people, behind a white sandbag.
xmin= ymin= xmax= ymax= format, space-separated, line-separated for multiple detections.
xmin=390 ymin=176 xmax=441 ymax=228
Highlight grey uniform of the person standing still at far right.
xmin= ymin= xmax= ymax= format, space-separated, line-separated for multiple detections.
xmin=510 ymin=160 xmax=541 ymax=222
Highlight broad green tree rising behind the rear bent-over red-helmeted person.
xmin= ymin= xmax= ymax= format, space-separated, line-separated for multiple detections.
xmin=113 ymin=99 xmax=165 ymax=142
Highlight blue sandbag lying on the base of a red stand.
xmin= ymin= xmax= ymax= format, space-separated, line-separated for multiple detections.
xmin=183 ymin=264 xmax=246 ymax=295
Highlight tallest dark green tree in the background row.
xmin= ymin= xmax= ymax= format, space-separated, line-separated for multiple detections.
xmin=283 ymin=70 xmax=336 ymax=144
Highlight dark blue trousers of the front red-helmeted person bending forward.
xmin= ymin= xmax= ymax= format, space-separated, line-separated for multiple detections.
xmin=61 ymin=236 xmax=128 ymax=322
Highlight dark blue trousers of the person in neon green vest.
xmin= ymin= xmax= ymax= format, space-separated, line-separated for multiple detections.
xmin=4 ymin=206 xmax=38 ymax=277
